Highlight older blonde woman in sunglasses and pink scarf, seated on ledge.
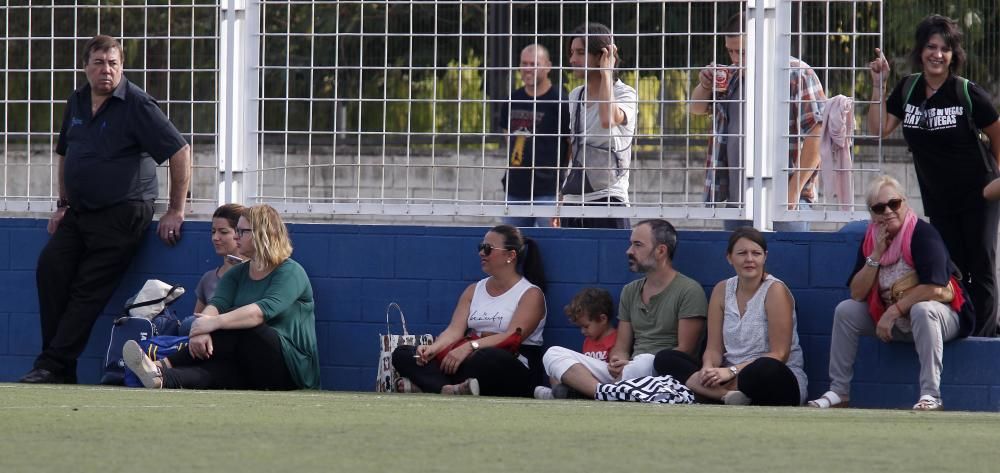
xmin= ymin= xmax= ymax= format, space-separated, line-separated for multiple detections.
xmin=809 ymin=176 xmax=975 ymax=410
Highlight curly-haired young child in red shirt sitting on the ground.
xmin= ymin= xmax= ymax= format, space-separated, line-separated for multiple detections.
xmin=535 ymin=287 xmax=618 ymax=399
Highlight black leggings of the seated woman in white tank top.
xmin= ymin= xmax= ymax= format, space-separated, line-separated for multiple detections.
xmin=392 ymin=345 xmax=543 ymax=397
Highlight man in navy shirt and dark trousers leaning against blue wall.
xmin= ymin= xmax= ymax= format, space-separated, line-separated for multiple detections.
xmin=20 ymin=35 xmax=191 ymax=384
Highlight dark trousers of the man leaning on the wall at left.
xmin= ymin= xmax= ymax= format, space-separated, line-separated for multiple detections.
xmin=35 ymin=202 xmax=153 ymax=379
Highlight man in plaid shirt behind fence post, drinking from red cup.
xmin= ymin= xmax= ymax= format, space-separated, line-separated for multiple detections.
xmin=689 ymin=13 xmax=826 ymax=232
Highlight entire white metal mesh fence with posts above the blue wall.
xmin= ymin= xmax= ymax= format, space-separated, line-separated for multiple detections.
xmin=0 ymin=0 xmax=1000 ymax=228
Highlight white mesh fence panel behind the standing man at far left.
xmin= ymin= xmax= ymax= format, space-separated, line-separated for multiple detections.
xmin=0 ymin=0 xmax=219 ymax=213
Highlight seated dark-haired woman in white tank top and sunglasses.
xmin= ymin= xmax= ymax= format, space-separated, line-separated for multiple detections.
xmin=392 ymin=225 xmax=546 ymax=397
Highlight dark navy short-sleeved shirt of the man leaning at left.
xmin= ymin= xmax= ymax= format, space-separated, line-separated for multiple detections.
xmin=56 ymin=76 xmax=187 ymax=210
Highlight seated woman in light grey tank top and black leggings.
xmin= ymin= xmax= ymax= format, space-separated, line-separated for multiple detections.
xmin=654 ymin=227 xmax=807 ymax=406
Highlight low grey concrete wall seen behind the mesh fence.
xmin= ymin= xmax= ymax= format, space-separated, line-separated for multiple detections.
xmin=6 ymin=144 xmax=923 ymax=231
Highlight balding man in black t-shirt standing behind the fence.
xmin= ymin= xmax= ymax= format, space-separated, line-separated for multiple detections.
xmin=501 ymin=44 xmax=569 ymax=227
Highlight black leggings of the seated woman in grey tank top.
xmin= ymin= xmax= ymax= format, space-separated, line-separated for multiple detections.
xmin=653 ymin=350 xmax=802 ymax=406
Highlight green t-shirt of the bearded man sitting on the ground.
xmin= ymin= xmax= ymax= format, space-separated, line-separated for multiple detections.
xmin=618 ymin=273 xmax=708 ymax=356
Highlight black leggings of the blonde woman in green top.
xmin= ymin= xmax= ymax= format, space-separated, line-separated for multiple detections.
xmin=163 ymin=324 xmax=299 ymax=391
